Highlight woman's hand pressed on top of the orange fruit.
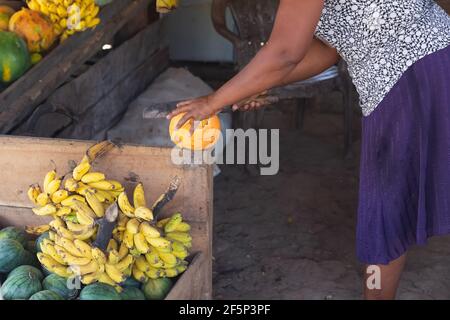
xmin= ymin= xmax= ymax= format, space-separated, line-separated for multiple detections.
xmin=167 ymin=95 xmax=223 ymax=129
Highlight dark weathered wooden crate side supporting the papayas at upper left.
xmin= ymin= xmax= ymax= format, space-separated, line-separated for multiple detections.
xmin=0 ymin=0 xmax=169 ymax=139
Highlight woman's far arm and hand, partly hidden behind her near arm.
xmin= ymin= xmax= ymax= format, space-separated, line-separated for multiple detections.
xmin=233 ymin=38 xmax=340 ymax=111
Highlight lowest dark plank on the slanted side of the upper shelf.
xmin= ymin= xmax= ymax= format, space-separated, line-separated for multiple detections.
xmin=57 ymin=49 xmax=169 ymax=139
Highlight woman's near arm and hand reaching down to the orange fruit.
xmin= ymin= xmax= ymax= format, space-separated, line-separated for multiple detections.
xmin=169 ymin=0 xmax=324 ymax=127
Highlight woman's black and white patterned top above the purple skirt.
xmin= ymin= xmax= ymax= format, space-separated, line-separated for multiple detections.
xmin=316 ymin=0 xmax=450 ymax=116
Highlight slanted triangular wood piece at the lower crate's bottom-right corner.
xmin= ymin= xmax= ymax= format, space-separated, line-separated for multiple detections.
xmin=165 ymin=252 xmax=211 ymax=300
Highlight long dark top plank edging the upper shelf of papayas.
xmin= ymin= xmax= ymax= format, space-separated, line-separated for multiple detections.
xmin=0 ymin=0 xmax=149 ymax=133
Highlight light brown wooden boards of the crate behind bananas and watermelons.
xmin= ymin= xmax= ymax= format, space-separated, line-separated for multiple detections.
xmin=0 ymin=136 xmax=213 ymax=299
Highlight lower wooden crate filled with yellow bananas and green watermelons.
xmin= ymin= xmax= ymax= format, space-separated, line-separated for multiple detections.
xmin=0 ymin=136 xmax=212 ymax=300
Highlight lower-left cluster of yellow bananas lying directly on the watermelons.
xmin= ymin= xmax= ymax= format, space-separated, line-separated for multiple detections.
xmin=38 ymin=218 xmax=134 ymax=291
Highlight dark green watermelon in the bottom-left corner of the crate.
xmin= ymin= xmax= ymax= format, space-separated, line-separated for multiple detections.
xmin=0 ymin=272 xmax=42 ymax=300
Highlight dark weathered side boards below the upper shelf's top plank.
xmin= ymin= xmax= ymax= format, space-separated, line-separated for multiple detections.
xmin=13 ymin=22 xmax=168 ymax=139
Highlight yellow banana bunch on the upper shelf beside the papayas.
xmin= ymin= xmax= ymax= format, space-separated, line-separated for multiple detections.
xmin=27 ymin=0 xmax=100 ymax=42
